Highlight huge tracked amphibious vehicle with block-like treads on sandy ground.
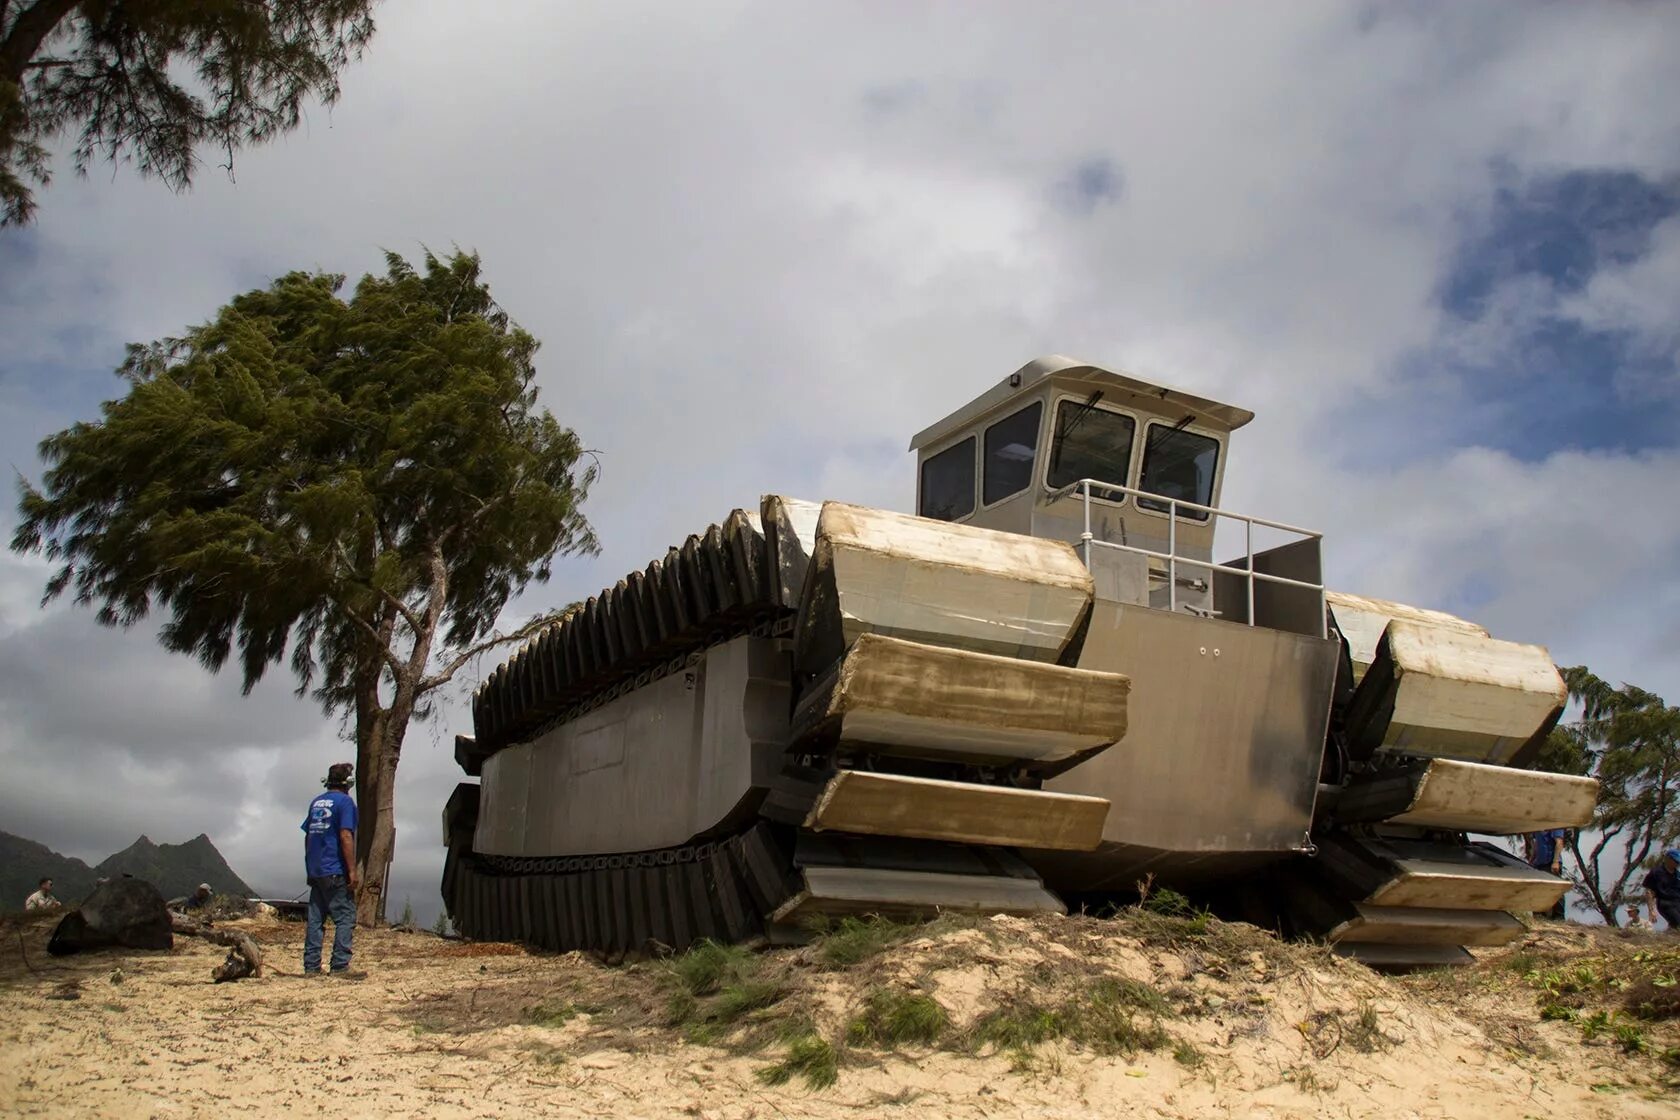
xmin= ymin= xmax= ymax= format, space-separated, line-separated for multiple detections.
xmin=444 ymin=356 xmax=1596 ymax=967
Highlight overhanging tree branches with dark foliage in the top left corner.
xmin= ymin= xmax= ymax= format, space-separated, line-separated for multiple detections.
xmin=0 ymin=0 xmax=373 ymax=225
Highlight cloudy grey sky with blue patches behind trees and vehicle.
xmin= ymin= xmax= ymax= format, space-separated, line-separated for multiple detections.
xmin=0 ymin=0 xmax=1680 ymax=915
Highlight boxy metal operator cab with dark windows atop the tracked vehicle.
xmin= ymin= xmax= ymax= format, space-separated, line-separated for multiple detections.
xmin=911 ymin=354 xmax=1322 ymax=633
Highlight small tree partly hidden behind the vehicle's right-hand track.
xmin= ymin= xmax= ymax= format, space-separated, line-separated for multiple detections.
xmin=1537 ymin=665 xmax=1680 ymax=925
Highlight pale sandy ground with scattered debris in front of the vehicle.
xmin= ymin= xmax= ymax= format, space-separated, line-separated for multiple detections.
xmin=0 ymin=919 xmax=1680 ymax=1120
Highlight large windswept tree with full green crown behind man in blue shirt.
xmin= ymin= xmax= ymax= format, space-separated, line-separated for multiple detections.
xmin=12 ymin=254 xmax=596 ymax=920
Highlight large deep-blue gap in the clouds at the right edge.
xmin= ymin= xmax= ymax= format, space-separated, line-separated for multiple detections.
xmin=1346 ymin=170 xmax=1680 ymax=463
